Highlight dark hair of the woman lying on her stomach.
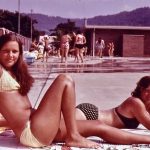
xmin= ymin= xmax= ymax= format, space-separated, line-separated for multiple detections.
xmin=131 ymin=76 xmax=150 ymax=98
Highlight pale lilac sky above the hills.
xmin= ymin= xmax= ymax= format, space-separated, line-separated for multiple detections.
xmin=0 ymin=0 xmax=150 ymax=18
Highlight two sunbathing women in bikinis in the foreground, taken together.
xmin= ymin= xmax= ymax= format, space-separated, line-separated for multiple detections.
xmin=0 ymin=34 xmax=150 ymax=148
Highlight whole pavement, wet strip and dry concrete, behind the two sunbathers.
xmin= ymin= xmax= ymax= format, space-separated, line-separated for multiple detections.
xmin=29 ymin=56 xmax=150 ymax=109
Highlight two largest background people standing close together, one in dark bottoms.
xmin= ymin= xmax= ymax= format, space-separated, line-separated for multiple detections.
xmin=60 ymin=30 xmax=86 ymax=63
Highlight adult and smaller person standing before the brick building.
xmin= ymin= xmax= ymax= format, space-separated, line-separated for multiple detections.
xmin=95 ymin=37 xmax=114 ymax=58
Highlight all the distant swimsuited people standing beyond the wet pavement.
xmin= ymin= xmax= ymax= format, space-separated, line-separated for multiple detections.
xmin=29 ymin=33 xmax=114 ymax=63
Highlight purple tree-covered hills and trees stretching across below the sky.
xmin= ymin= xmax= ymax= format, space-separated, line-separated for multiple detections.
xmin=0 ymin=7 xmax=150 ymax=37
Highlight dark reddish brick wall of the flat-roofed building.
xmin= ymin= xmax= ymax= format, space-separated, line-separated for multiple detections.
xmin=86 ymin=29 xmax=150 ymax=57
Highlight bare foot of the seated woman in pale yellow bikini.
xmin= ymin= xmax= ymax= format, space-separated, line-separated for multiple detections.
xmin=66 ymin=135 xmax=100 ymax=149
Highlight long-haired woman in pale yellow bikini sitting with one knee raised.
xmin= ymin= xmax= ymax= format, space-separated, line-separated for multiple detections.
xmin=0 ymin=34 xmax=150 ymax=148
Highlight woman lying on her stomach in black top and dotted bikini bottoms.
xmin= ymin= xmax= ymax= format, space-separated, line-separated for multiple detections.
xmin=76 ymin=76 xmax=150 ymax=129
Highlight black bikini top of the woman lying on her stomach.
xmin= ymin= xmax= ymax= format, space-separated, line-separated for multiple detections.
xmin=115 ymin=108 xmax=139 ymax=129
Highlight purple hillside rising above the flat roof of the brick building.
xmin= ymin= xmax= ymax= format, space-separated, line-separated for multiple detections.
xmin=88 ymin=7 xmax=150 ymax=26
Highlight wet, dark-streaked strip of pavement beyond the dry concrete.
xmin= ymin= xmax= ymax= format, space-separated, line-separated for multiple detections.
xmin=31 ymin=57 xmax=150 ymax=73
